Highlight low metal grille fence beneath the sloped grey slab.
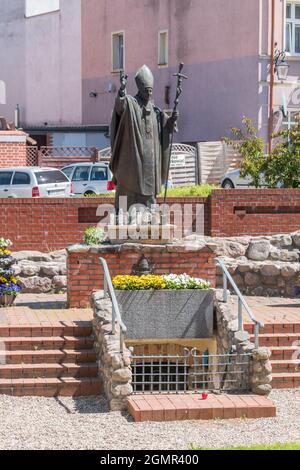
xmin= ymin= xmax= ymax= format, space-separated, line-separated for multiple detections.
xmin=131 ymin=348 xmax=252 ymax=394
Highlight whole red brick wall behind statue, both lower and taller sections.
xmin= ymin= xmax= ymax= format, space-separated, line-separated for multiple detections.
xmin=4 ymin=189 xmax=300 ymax=251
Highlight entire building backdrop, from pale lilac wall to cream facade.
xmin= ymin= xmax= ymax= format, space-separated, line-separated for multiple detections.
xmin=0 ymin=0 xmax=300 ymax=147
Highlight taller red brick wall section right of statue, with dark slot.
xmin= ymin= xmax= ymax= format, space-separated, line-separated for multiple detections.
xmin=211 ymin=189 xmax=300 ymax=237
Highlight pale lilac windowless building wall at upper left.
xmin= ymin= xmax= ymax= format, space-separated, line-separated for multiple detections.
xmin=0 ymin=0 xmax=107 ymax=146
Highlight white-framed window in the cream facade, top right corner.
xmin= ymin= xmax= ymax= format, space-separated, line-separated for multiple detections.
xmin=285 ymin=2 xmax=300 ymax=55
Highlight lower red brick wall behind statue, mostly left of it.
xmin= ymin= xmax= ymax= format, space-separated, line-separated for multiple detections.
xmin=0 ymin=198 xmax=209 ymax=251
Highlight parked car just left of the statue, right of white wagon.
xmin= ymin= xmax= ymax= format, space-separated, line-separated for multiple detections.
xmin=62 ymin=163 xmax=115 ymax=196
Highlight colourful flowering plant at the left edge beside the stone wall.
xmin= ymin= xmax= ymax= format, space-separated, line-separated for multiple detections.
xmin=0 ymin=238 xmax=22 ymax=307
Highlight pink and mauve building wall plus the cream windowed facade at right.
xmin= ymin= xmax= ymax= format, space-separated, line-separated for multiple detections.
xmin=82 ymin=0 xmax=300 ymax=142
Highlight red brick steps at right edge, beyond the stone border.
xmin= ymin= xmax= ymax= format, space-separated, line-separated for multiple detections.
xmin=245 ymin=323 xmax=300 ymax=388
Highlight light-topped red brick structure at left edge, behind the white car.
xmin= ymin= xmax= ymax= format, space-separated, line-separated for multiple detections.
xmin=0 ymin=131 xmax=27 ymax=168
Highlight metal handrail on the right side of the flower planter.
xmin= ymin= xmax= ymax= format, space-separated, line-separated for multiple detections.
xmin=216 ymin=258 xmax=264 ymax=348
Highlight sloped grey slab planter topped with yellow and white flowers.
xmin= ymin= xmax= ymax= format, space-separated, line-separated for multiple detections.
xmin=113 ymin=274 xmax=214 ymax=339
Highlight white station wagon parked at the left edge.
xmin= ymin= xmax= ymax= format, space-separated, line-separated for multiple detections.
xmin=0 ymin=166 xmax=72 ymax=198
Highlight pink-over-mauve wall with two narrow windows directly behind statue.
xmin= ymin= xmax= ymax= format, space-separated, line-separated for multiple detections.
xmin=82 ymin=0 xmax=260 ymax=142
